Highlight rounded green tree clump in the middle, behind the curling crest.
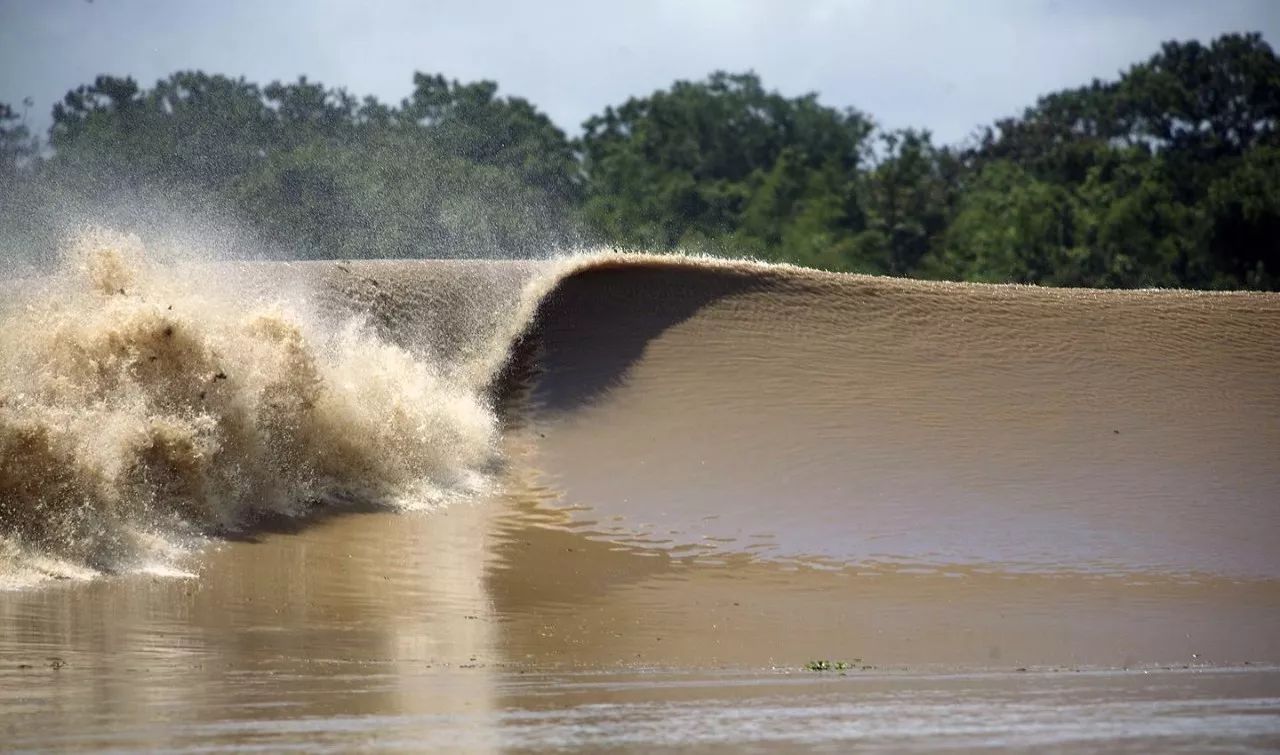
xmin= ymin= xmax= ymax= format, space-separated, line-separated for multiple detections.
xmin=580 ymin=73 xmax=872 ymax=248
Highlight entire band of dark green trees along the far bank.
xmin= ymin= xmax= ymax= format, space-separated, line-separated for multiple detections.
xmin=0 ymin=33 xmax=1280 ymax=289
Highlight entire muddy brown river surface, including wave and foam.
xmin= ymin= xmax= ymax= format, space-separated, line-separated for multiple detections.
xmin=0 ymin=230 xmax=1280 ymax=751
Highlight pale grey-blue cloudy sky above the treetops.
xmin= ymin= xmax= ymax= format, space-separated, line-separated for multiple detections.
xmin=0 ymin=0 xmax=1280 ymax=142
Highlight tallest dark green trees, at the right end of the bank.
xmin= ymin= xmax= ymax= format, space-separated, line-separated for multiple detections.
xmin=962 ymin=33 xmax=1280 ymax=288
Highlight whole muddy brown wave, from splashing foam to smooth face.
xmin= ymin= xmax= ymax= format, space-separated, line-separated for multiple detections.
xmin=0 ymin=232 xmax=1280 ymax=585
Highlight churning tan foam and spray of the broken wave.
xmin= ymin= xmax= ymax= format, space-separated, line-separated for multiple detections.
xmin=0 ymin=229 xmax=497 ymax=576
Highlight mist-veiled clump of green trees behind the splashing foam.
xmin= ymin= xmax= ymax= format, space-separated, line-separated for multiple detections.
xmin=30 ymin=72 xmax=580 ymax=256
